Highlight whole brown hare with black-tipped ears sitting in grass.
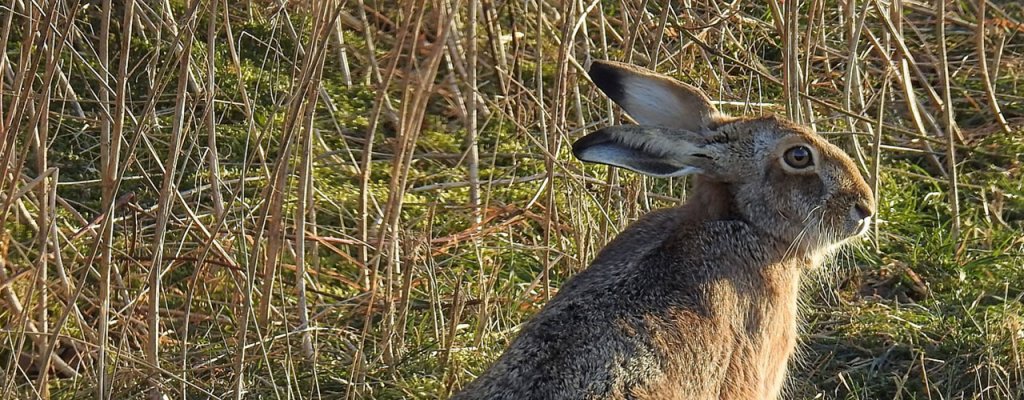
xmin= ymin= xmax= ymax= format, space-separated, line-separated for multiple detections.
xmin=454 ymin=61 xmax=874 ymax=400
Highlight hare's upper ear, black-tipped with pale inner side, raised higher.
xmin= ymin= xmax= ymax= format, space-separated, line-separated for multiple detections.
xmin=588 ymin=61 xmax=719 ymax=132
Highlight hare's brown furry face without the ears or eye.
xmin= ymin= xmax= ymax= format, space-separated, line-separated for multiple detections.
xmin=713 ymin=117 xmax=873 ymax=257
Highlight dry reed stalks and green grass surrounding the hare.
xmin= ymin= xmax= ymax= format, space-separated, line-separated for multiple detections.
xmin=0 ymin=0 xmax=1024 ymax=399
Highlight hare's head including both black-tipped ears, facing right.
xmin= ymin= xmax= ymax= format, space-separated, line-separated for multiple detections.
xmin=572 ymin=61 xmax=874 ymax=255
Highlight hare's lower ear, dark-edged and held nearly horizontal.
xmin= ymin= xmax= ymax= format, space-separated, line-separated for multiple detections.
xmin=572 ymin=125 xmax=722 ymax=177
